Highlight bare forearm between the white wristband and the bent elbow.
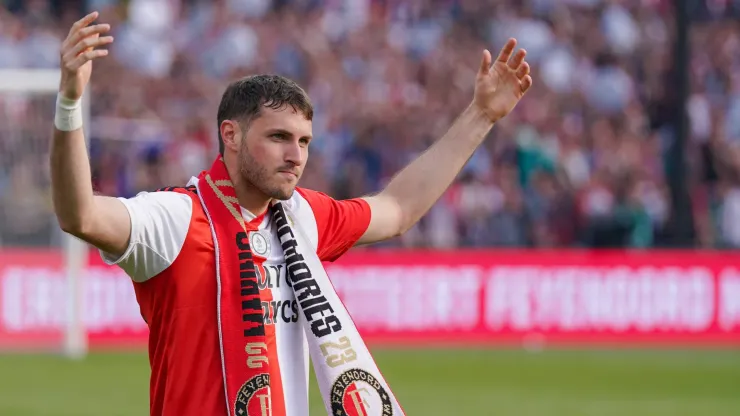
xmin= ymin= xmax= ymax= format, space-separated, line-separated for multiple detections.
xmin=50 ymin=128 xmax=94 ymax=234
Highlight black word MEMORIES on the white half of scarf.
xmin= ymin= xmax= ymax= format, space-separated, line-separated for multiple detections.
xmin=274 ymin=205 xmax=342 ymax=338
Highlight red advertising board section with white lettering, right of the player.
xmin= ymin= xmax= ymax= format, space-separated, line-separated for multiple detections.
xmin=327 ymin=251 xmax=740 ymax=347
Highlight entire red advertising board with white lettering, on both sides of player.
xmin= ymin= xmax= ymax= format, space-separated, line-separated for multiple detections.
xmin=0 ymin=250 xmax=740 ymax=348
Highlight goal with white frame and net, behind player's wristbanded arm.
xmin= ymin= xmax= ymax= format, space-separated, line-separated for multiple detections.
xmin=0 ymin=69 xmax=89 ymax=358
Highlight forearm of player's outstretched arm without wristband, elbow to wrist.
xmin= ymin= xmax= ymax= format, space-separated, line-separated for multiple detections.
xmin=381 ymin=105 xmax=493 ymax=232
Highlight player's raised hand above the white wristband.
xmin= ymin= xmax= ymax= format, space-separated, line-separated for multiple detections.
xmin=59 ymin=12 xmax=113 ymax=100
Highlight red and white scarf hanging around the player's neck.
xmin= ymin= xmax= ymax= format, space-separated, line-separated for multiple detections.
xmin=197 ymin=157 xmax=404 ymax=416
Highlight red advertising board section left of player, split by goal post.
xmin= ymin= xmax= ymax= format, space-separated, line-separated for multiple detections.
xmin=0 ymin=250 xmax=148 ymax=349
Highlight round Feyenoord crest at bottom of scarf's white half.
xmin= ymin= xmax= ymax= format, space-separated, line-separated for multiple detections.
xmin=331 ymin=368 xmax=393 ymax=416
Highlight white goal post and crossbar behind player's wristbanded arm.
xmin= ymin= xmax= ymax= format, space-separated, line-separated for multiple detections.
xmin=0 ymin=69 xmax=90 ymax=358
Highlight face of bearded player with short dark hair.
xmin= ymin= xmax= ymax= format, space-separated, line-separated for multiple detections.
xmin=238 ymin=106 xmax=312 ymax=200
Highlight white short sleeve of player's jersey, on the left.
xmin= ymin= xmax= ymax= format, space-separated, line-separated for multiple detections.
xmin=100 ymin=192 xmax=193 ymax=282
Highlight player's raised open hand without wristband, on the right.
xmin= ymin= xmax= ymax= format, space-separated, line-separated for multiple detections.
xmin=473 ymin=38 xmax=532 ymax=123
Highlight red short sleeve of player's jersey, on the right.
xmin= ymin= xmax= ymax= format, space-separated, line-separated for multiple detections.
xmin=299 ymin=189 xmax=370 ymax=261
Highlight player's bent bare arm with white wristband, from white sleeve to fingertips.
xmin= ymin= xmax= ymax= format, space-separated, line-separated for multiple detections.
xmin=50 ymin=12 xmax=131 ymax=255
